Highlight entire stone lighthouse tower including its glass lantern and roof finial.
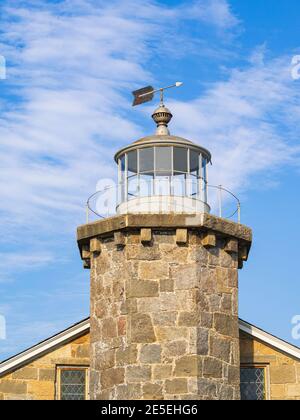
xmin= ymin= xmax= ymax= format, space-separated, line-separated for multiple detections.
xmin=78 ymin=100 xmax=251 ymax=399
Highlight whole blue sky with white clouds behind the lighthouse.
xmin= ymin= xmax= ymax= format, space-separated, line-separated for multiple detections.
xmin=0 ymin=0 xmax=300 ymax=359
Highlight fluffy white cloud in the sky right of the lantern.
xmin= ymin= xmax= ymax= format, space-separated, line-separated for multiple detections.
xmin=170 ymin=53 xmax=300 ymax=197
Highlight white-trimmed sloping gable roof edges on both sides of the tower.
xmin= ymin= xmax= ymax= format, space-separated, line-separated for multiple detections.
xmin=0 ymin=318 xmax=300 ymax=377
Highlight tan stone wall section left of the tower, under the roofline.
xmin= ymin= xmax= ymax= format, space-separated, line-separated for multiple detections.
xmin=0 ymin=334 xmax=90 ymax=400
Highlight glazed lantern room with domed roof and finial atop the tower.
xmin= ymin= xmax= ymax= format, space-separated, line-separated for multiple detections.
xmin=115 ymin=104 xmax=211 ymax=214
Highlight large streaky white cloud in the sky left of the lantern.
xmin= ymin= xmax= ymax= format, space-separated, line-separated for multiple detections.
xmin=0 ymin=0 xmax=241 ymax=240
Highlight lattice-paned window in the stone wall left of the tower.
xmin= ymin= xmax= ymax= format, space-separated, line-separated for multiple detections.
xmin=57 ymin=367 xmax=88 ymax=401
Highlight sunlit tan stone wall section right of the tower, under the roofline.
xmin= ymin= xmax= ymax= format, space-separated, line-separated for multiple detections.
xmin=240 ymin=332 xmax=300 ymax=400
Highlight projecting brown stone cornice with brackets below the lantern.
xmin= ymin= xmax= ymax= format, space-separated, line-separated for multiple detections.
xmin=77 ymin=213 xmax=252 ymax=268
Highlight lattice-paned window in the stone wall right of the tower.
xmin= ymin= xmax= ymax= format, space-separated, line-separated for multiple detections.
xmin=241 ymin=367 xmax=266 ymax=401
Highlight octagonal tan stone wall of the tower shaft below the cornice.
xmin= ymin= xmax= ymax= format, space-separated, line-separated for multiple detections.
xmin=89 ymin=229 xmax=244 ymax=399
